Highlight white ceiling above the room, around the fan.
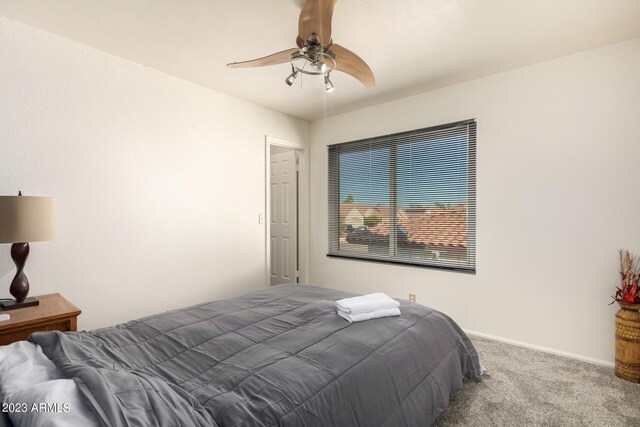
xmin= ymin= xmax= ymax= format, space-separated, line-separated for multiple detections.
xmin=0 ymin=0 xmax=640 ymax=120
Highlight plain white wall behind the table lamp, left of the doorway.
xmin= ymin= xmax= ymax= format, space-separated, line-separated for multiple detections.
xmin=0 ymin=19 xmax=309 ymax=329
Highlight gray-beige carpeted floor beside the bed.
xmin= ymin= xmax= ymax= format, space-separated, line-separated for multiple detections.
xmin=434 ymin=336 xmax=640 ymax=427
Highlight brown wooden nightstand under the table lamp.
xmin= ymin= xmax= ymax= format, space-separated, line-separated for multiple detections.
xmin=0 ymin=294 xmax=80 ymax=345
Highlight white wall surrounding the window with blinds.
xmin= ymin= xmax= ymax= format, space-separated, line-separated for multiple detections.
xmin=310 ymin=39 xmax=640 ymax=363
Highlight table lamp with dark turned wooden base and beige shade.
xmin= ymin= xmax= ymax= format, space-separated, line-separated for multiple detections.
xmin=0 ymin=193 xmax=56 ymax=310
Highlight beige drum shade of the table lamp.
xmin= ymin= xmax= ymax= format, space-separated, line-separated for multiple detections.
xmin=0 ymin=196 xmax=57 ymax=243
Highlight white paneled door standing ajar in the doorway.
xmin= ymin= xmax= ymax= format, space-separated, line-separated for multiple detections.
xmin=269 ymin=150 xmax=298 ymax=286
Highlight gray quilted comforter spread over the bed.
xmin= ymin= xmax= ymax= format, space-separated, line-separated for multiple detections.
xmin=29 ymin=285 xmax=480 ymax=427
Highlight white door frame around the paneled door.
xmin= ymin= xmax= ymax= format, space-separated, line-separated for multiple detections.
xmin=264 ymin=135 xmax=309 ymax=287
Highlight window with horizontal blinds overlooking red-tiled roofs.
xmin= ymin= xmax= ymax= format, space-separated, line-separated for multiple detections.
xmin=329 ymin=120 xmax=476 ymax=272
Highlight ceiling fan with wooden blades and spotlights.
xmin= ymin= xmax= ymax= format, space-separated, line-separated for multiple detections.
xmin=227 ymin=0 xmax=376 ymax=92
